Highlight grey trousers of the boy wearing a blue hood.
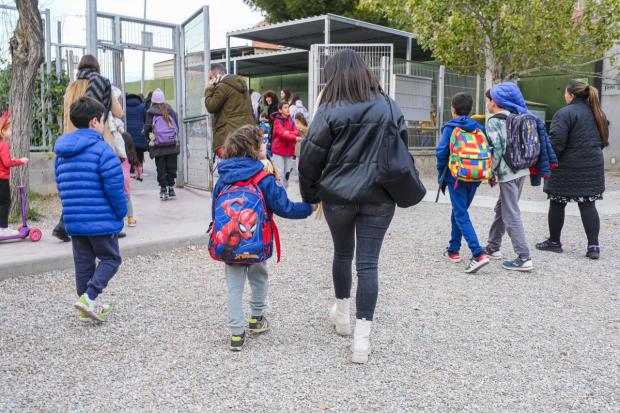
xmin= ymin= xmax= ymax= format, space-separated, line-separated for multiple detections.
xmin=488 ymin=176 xmax=531 ymax=259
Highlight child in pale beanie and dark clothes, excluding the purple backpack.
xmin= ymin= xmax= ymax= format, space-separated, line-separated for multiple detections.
xmin=144 ymin=89 xmax=181 ymax=201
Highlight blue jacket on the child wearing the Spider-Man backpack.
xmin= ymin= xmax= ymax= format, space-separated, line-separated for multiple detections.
xmin=211 ymin=157 xmax=312 ymax=219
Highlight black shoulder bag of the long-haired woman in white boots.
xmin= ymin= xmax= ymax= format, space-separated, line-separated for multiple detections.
xmin=377 ymin=98 xmax=426 ymax=208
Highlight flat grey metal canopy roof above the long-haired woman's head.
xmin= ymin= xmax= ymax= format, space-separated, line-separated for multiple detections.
xmin=226 ymin=14 xmax=430 ymax=76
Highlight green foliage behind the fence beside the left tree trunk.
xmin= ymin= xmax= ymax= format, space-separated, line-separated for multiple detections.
xmin=0 ymin=61 xmax=69 ymax=150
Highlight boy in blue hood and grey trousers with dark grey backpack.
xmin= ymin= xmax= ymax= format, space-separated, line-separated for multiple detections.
xmin=486 ymin=82 xmax=542 ymax=271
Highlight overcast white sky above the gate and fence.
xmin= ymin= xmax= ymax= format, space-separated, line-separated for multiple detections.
xmin=0 ymin=0 xmax=263 ymax=81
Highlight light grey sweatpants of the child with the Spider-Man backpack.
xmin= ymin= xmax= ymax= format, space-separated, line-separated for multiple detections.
xmin=225 ymin=262 xmax=269 ymax=335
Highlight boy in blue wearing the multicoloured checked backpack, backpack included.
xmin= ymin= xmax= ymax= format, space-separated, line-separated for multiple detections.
xmin=436 ymin=93 xmax=492 ymax=273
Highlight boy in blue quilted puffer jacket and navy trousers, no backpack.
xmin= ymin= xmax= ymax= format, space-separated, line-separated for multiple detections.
xmin=55 ymin=97 xmax=127 ymax=321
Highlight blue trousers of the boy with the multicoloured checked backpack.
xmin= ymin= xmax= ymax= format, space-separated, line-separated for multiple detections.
xmin=448 ymin=181 xmax=484 ymax=257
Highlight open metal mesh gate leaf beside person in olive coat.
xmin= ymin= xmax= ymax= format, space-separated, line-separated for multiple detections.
xmin=180 ymin=6 xmax=213 ymax=190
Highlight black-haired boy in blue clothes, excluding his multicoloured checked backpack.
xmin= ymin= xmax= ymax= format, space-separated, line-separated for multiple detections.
xmin=436 ymin=93 xmax=489 ymax=273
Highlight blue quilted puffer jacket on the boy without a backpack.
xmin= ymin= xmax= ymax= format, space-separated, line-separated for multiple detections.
xmin=54 ymin=129 xmax=127 ymax=236
